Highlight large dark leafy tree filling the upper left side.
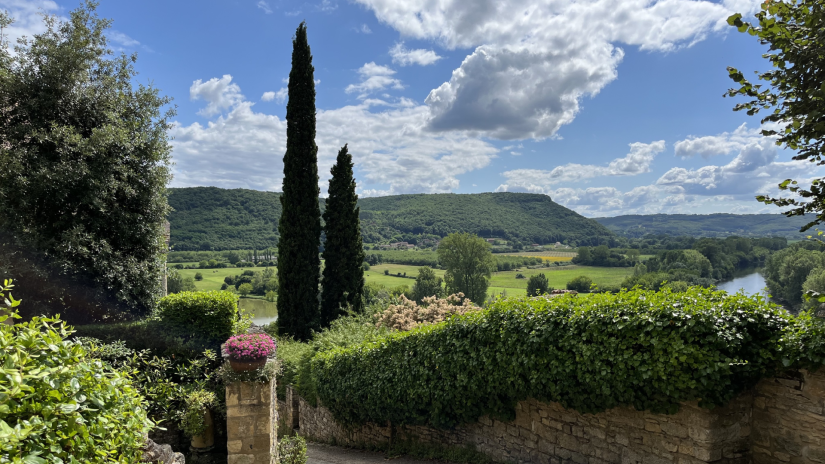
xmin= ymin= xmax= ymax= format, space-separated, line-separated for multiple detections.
xmin=0 ymin=1 xmax=173 ymax=313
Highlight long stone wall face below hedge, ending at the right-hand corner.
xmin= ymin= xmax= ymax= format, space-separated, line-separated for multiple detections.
xmin=292 ymin=388 xmax=751 ymax=464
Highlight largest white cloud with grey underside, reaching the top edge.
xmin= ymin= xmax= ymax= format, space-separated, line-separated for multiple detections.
xmin=357 ymin=0 xmax=759 ymax=139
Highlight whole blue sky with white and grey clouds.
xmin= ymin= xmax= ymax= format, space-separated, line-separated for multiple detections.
xmin=0 ymin=0 xmax=822 ymax=217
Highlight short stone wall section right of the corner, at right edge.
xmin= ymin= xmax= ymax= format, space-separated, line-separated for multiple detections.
xmin=751 ymin=368 xmax=825 ymax=464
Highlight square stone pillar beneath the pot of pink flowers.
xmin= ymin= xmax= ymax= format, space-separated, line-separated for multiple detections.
xmin=226 ymin=378 xmax=278 ymax=464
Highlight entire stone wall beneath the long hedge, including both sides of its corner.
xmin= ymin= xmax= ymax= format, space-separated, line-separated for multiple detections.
xmin=281 ymin=372 xmax=825 ymax=464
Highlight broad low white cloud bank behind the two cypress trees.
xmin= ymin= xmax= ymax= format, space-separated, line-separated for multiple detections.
xmin=170 ymin=76 xmax=498 ymax=196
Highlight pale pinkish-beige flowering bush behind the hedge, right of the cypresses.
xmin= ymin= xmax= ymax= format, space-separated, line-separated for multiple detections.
xmin=375 ymin=293 xmax=480 ymax=331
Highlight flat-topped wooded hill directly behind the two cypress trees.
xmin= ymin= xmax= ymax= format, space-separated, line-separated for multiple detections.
xmin=169 ymin=187 xmax=615 ymax=251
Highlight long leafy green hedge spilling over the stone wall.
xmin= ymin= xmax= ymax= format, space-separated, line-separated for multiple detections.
xmin=311 ymin=287 xmax=825 ymax=427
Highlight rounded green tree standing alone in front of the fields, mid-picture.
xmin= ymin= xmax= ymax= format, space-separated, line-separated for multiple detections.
xmin=438 ymin=233 xmax=495 ymax=305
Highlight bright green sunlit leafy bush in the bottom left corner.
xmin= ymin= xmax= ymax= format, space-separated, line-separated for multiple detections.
xmin=0 ymin=317 xmax=152 ymax=463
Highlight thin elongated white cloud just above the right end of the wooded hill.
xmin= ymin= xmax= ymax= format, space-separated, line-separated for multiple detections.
xmin=502 ymin=140 xmax=665 ymax=188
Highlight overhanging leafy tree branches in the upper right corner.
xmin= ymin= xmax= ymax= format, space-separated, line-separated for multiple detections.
xmin=728 ymin=0 xmax=825 ymax=230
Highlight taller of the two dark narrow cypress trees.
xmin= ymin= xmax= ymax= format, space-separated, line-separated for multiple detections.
xmin=278 ymin=22 xmax=321 ymax=340
